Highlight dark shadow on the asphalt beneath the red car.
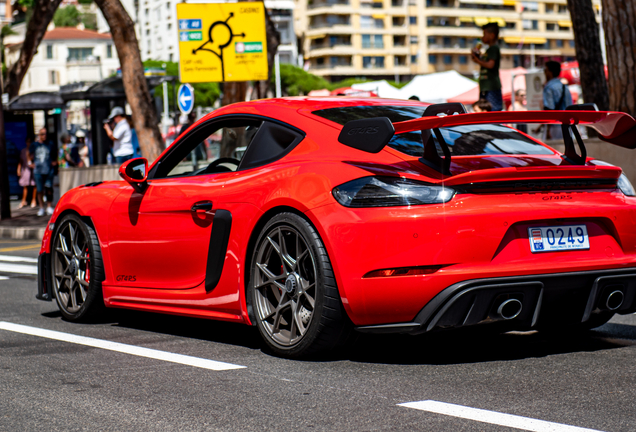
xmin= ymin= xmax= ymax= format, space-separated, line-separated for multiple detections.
xmin=42 ymin=309 xmax=636 ymax=365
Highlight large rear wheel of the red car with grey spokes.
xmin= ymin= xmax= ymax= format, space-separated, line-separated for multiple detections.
xmin=247 ymin=213 xmax=352 ymax=358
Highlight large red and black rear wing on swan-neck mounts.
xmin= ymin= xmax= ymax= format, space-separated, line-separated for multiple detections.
xmin=338 ymin=104 xmax=636 ymax=175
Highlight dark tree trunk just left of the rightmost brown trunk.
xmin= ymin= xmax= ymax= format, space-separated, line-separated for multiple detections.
xmin=568 ymin=0 xmax=609 ymax=111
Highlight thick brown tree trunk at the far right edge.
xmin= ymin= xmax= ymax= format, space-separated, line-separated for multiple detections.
xmin=603 ymin=0 xmax=636 ymax=116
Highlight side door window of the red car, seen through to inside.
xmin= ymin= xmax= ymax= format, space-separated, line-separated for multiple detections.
xmin=152 ymin=120 xmax=263 ymax=179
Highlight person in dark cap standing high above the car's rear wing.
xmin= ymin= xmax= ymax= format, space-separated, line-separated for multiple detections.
xmin=470 ymin=23 xmax=503 ymax=111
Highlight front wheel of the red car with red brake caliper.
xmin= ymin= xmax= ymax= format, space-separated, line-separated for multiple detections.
xmin=50 ymin=214 xmax=104 ymax=321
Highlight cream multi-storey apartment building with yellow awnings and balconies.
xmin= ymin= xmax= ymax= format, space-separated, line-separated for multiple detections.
xmin=295 ymin=0 xmax=600 ymax=80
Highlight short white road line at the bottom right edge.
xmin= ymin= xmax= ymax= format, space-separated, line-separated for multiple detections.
xmin=398 ymin=400 xmax=600 ymax=432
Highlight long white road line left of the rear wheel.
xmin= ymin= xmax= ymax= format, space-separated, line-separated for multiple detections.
xmin=0 ymin=321 xmax=245 ymax=371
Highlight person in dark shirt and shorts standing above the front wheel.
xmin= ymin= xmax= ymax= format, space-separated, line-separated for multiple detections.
xmin=30 ymin=128 xmax=57 ymax=216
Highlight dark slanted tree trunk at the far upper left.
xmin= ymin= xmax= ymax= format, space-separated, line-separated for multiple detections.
xmin=5 ymin=0 xmax=62 ymax=99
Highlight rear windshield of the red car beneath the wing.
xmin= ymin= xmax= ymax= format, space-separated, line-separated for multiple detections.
xmin=312 ymin=106 xmax=553 ymax=156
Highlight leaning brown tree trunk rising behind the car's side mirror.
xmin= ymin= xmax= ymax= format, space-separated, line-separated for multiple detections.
xmin=95 ymin=0 xmax=164 ymax=162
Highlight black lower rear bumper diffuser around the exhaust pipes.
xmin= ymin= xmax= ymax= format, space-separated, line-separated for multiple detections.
xmin=356 ymin=268 xmax=636 ymax=334
